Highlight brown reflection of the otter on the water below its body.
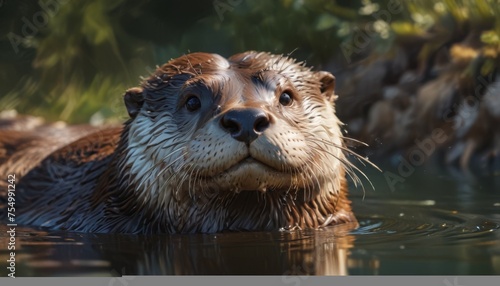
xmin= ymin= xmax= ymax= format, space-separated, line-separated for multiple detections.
xmin=1 ymin=224 xmax=355 ymax=276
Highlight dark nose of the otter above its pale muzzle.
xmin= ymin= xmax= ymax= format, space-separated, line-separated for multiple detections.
xmin=221 ymin=108 xmax=269 ymax=144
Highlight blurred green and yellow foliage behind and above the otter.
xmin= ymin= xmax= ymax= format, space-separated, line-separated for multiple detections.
xmin=0 ymin=0 xmax=500 ymax=122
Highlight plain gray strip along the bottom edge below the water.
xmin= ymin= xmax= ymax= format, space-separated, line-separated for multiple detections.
xmin=0 ymin=276 xmax=500 ymax=286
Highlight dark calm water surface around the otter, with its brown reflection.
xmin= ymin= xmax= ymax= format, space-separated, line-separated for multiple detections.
xmin=0 ymin=162 xmax=500 ymax=276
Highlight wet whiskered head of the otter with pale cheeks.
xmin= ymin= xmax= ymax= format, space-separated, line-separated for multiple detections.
xmin=121 ymin=52 xmax=350 ymax=230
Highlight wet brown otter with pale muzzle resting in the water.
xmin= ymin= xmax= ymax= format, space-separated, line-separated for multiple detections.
xmin=0 ymin=52 xmax=356 ymax=233
